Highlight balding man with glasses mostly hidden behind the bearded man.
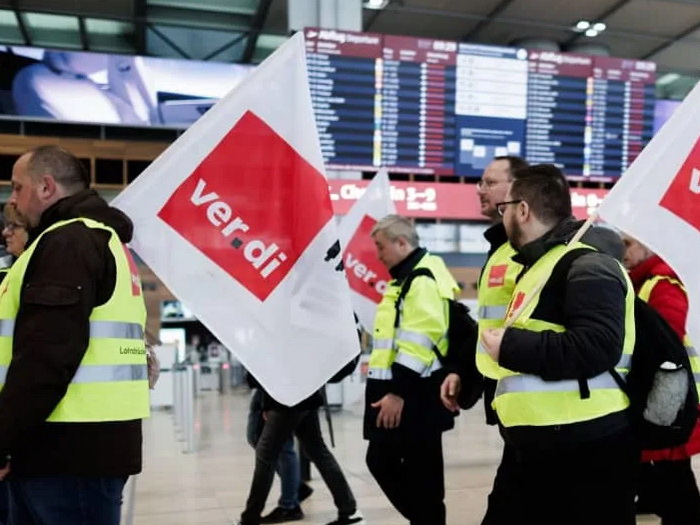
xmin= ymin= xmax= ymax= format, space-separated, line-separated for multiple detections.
xmin=442 ymin=156 xmax=527 ymax=525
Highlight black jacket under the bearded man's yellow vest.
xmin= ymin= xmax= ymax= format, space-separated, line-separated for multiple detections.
xmin=499 ymin=219 xmax=628 ymax=445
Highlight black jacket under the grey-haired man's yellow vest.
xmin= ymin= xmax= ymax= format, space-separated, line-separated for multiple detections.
xmin=363 ymin=248 xmax=454 ymax=439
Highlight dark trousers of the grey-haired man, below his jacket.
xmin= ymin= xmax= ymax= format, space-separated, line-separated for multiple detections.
xmin=367 ymin=432 xmax=445 ymax=525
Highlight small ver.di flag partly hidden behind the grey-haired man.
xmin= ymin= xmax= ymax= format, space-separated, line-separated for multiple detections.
xmin=338 ymin=169 xmax=396 ymax=333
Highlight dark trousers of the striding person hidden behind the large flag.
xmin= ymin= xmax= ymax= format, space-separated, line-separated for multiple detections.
xmin=241 ymin=408 xmax=357 ymax=525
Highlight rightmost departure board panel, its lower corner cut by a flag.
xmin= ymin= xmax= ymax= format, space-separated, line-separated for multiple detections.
xmin=583 ymin=57 xmax=656 ymax=180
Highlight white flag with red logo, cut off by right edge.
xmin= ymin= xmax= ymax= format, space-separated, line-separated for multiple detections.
xmin=598 ymin=84 xmax=700 ymax=345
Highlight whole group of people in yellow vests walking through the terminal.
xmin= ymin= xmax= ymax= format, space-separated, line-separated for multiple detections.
xmin=0 ymin=146 xmax=700 ymax=525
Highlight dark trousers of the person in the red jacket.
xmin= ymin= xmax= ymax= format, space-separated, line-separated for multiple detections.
xmin=638 ymin=458 xmax=700 ymax=525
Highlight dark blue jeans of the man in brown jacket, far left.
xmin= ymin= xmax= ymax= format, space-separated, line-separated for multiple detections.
xmin=7 ymin=476 xmax=126 ymax=525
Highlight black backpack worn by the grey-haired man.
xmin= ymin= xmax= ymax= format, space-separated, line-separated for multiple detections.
xmin=394 ymin=268 xmax=484 ymax=410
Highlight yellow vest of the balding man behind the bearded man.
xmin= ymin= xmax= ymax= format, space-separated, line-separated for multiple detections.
xmin=476 ymin=242 xmax=522 ymax=379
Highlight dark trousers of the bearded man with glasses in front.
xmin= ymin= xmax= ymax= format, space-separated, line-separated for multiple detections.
xmin=516 ymin=431 xmax=639 ymax=525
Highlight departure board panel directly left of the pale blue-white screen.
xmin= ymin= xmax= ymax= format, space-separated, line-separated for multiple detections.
xmin=381 ymin=35 xmax=457 ymax=174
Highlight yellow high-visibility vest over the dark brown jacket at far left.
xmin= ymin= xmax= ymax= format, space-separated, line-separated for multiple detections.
xmin=0 ymin=219 xmax=149 ymax=422
